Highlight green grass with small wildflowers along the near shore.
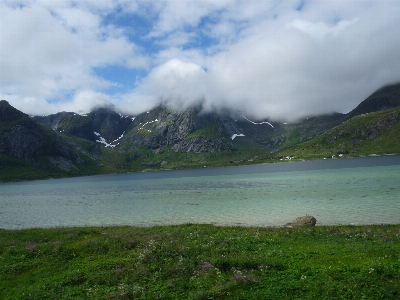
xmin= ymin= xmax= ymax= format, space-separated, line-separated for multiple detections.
xmin=0 ymin=224 xmax=400 ymax=299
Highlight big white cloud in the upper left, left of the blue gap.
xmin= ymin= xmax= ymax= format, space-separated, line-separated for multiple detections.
xmin=0 ymin=1 xmax=148 ymax=113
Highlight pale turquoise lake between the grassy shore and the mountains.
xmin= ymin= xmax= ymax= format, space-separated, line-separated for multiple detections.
xmin=0 ymin=155 xmax=400 ymax=229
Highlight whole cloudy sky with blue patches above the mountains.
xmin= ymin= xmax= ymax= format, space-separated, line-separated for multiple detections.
xmin=0 ymin=0 xmax=400 ymax=121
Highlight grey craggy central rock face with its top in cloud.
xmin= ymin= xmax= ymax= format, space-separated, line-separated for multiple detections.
xmin=120 ymin=107 xmax=234 ymax=153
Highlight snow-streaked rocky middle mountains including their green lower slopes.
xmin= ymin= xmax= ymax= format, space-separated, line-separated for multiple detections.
xmin=32 ymin=106 xmax=280 ymax=172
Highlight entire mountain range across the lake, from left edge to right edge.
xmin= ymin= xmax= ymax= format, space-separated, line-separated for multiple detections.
xmin=0 ymin=84 xmax=400 ymax=180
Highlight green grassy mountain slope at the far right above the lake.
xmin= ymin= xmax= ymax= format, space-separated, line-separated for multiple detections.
xmin=277 ymin=83 xmax=400 ymax=158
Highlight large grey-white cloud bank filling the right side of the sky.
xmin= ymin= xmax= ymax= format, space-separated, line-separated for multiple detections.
xmin=134 ymin=1 xmax=400 ymax=120
